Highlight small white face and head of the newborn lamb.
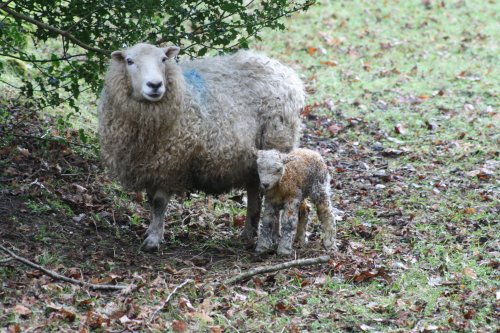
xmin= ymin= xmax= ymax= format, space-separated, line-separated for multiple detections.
xmin=257 ymin=149 xmax=287 ymax=191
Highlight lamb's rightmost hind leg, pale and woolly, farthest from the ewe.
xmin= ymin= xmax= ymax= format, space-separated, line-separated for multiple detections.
xmin=314 ymin=187 xmax=337 ymax=250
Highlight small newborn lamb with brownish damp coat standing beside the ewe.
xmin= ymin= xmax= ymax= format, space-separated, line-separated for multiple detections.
xmin=255 ymin=149 xmax=336 ymax=256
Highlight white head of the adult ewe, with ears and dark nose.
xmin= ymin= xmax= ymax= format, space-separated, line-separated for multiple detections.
xmin=111 ymin=43 xmax=180 ymax=102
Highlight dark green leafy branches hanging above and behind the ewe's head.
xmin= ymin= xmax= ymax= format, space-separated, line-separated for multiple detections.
xmin=0 ymin=0 xmax=316 ymax=110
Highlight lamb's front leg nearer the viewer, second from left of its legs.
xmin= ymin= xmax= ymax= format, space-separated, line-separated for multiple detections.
xmin=276 ymin=199 xmax=300 ymax=256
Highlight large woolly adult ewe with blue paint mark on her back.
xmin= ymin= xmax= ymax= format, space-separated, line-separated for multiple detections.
xmin=95 ymin=44 xmax=304 ymax=250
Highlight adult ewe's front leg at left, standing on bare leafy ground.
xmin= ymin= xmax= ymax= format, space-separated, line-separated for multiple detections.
xmin=142 ymin=190 xmax=170 ymax=251
